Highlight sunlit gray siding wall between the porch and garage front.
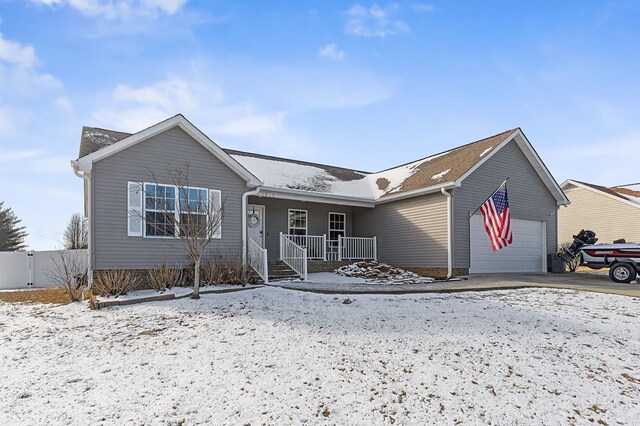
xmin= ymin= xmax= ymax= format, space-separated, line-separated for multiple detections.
xmin=353 ymin=193 xmax=447 ymax=268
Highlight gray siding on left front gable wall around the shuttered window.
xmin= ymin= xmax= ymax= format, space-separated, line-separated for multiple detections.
xmin=91 ymin=127 xmax=246 ymax=269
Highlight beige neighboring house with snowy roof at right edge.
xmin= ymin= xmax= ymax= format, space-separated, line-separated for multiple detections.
xmin=558 ymin=180 xmax=640 ymax=244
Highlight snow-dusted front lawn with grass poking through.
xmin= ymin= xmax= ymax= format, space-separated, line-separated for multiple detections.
xmin=0 ymin=288 xmax=640 ymax=425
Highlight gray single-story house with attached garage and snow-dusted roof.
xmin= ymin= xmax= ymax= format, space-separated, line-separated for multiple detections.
xmin=72 ymin=115 xmax=568 ymax=277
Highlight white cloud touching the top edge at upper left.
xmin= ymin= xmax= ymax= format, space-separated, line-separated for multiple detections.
xmin=31 ymin=0 xmax=187 ymax=21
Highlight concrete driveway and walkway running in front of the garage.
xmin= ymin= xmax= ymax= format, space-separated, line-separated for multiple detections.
xmin=268 ymin=273 xmax=640 ymax=298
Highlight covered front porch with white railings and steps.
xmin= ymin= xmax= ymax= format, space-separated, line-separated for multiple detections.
xmin=246 ymin=195 xmax=378 ymax=282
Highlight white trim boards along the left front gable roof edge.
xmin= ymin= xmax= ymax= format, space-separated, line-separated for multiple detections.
xmin=74 ymin=114 xmax=262 ymax=187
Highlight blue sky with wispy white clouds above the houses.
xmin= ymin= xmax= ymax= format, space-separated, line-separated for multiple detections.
xmin=0 ymin=0 xmax=640 ymax=249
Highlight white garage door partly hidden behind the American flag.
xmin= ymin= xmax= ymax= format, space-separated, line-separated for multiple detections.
xmin=469 ymin=215 xmax=546 ymax=274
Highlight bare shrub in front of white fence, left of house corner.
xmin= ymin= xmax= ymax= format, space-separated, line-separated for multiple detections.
xmin=44 ymin=250 xmax=88 ymax=302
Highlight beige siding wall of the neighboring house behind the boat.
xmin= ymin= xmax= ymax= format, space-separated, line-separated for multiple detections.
xmin=558 ymin=188 xmax=640 ymax=244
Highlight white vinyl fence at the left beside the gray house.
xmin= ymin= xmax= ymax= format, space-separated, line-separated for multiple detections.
xmin=0 ymin=250 xmax=88 ymax=290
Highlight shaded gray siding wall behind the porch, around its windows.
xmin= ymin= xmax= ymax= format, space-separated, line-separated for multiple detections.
xmin=249 ymin=197 xmax=352 ymax=261
